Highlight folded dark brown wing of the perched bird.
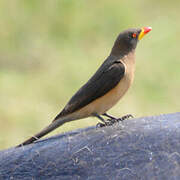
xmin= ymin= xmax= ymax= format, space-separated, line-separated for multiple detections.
xmin=55 ymin=61 xmax=125 ymax=120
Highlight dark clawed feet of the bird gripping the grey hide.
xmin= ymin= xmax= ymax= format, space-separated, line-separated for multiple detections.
xmin=96 ymin=114 xmax=133 ymax=128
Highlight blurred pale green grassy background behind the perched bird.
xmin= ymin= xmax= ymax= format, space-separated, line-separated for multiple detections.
xmin=0 ymin=0 xmax=180 ymax=149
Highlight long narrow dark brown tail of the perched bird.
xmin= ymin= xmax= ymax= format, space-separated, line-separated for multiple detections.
xmin=16 ymin=118 xmax=67 ymax=147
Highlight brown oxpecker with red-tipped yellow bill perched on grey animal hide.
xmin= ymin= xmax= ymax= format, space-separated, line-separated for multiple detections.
xmin=17 ymin=27 xmax=152 ymax=147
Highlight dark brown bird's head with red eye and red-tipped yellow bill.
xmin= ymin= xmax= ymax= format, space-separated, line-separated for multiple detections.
xmin=111 ymin=27 xmax=152 ymax=56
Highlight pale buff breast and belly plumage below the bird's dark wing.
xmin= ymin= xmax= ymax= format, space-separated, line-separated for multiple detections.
xmin=74 ymin=53 xmax=135 ymax=117
